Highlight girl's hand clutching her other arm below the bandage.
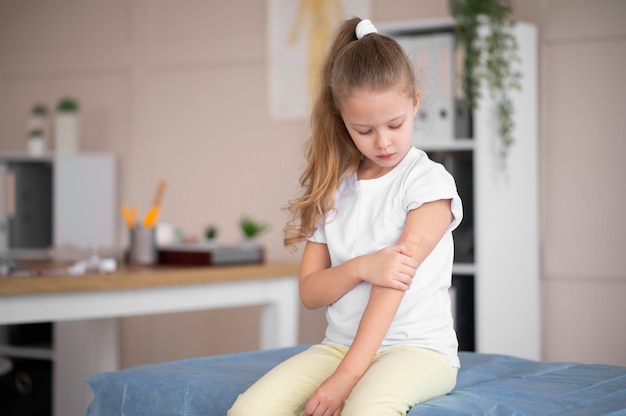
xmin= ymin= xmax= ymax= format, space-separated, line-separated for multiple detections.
xmin=354 ymin=244 xmax=419 ymax=290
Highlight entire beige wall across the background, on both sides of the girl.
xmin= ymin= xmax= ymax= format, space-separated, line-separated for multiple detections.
xmin=0 ymin=0 xmax=626 ymax=366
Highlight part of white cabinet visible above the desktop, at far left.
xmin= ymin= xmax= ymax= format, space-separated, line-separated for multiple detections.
xmin=0 ymin=153 xmax=118 ymax=256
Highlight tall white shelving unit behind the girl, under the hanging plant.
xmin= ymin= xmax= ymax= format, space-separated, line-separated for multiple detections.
xmin=379 ymin=19 xmax=541 ymax=359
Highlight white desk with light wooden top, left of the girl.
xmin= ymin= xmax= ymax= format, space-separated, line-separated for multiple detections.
xmin=0 ymin=264 xmax=299 ymax=416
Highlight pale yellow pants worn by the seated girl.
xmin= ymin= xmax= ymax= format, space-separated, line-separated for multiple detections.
xmin=228 ymin=345 xmax=458 ymax=416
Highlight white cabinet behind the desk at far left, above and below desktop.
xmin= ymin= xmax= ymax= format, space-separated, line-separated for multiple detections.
xmin=0 ymin=153 xmax=119 ymax=416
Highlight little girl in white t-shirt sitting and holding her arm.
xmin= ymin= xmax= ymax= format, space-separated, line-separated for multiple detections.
xmin=229 ymin=18 xmax=462 ymax=416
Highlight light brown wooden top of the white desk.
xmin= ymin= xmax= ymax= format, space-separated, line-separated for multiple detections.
xmin=0 ymin=263 xmax=299 ymax=297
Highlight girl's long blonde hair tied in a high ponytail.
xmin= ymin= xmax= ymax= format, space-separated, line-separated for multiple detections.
xmin=284 ymin=17 xmax=416 ymax=247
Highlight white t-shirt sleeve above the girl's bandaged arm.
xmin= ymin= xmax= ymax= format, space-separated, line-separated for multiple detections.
xmin=403 ymin=159 xmax=463 ymax=231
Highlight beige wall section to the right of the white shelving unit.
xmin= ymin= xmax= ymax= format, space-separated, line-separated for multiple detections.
xmin=541 ymin=0 xmax=626 ymax=365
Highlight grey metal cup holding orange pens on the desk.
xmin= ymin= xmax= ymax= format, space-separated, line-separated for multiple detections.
xmin=121 ymin=181 xmax=165 ymax=265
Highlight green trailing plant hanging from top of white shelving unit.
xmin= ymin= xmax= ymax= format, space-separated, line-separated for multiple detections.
xmin=450 ymin=0 xmax=521 ymax=168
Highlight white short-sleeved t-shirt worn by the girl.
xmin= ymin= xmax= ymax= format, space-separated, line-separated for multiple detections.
xmin=310 ymin=148 xmax=463 ymax=367
